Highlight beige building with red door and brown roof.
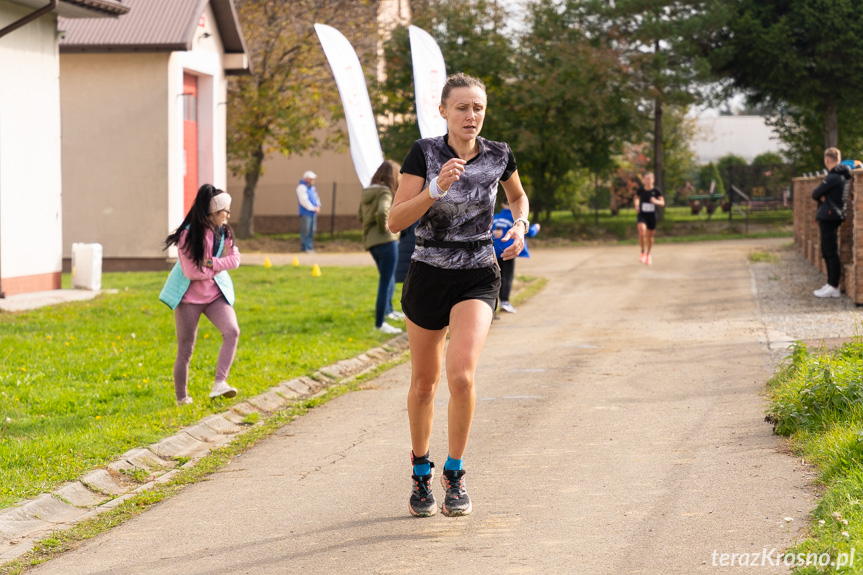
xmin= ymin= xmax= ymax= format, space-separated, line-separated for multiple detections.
xmin=59 ymin=0 xmax=249 ymax=271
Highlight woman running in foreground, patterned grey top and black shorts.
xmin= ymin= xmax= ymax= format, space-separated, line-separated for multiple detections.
xmin=389 ymin=74 xmax=529 ymax=517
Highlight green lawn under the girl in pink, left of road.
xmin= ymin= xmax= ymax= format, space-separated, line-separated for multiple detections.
xmin=0 ymin=266 xmax=400 ymax=508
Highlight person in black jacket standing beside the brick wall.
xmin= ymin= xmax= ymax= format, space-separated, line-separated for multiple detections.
xmin=812 ymin=148 xmax=851 ymax=297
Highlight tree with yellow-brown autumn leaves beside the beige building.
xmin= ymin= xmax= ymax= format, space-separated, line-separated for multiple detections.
xmin=228 ymin=0 xmax=377 ymax=237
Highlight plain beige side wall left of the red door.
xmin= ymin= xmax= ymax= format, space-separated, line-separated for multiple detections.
xmin=60 ymin=53 xmax=168 ymax=258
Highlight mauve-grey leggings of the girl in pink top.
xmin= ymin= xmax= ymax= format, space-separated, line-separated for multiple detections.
xmin=174 ymin=297 xmax=240 ymax=400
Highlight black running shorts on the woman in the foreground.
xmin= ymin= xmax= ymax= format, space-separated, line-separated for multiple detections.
xmin=402 ymin=261 xmax=500 ymax=330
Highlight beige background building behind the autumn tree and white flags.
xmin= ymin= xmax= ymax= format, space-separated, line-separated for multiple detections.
xmin=227 ymin=0 xmax=412 ymax=233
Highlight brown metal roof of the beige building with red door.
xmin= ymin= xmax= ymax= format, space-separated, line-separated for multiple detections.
xmin=58 ymin=0 xmax=247 ymax=71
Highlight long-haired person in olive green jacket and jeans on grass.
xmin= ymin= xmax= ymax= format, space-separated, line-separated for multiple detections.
xmin=357 ymin=160 xmax=404 ymax=335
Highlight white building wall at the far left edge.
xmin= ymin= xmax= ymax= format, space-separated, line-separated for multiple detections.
xmin=0 ymin=0 xmax=62 ymax=295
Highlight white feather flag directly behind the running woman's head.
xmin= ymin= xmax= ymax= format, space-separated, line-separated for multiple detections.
xmin=408 ymin=26 xmax=446 ymax=138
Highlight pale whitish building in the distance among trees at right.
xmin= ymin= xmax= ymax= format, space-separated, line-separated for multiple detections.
xmin=691 ymin=116 xmax=782 ymax=164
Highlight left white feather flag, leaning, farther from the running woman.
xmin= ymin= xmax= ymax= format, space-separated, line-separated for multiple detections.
xmin=315 ymin=24 xmax=384 ymax=187
